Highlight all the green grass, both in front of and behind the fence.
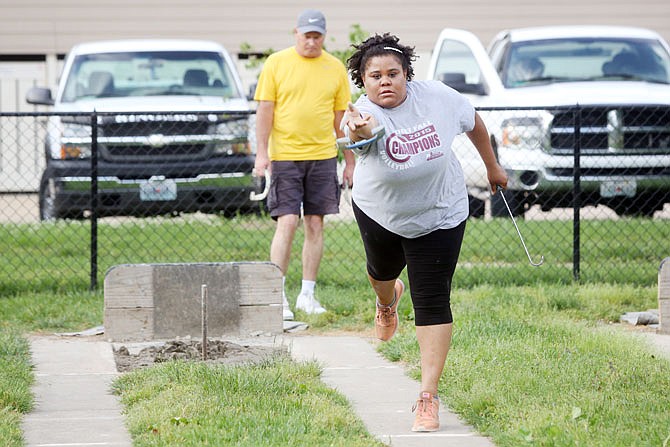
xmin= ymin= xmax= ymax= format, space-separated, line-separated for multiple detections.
xmin=0 ymin=217 xmax=670 ymax=447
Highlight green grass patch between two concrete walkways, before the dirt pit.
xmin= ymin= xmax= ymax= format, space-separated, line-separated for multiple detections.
xmin=114 ymin=356 xmax=383 ymax=447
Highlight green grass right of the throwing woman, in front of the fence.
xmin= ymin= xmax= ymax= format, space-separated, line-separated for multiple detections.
xmin=382 ymin=286 xmax=670 ymax=447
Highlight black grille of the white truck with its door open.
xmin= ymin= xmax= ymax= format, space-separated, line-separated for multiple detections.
xmin=551 ymin=106 xmax=670 ymax=155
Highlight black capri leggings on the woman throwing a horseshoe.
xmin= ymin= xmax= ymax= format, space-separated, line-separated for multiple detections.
xmin=352 ymin=203 xmax=466 ymax=326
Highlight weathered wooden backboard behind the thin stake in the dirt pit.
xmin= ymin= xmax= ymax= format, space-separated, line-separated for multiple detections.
xmin=104 ymin=262 xmax=283 ymax=341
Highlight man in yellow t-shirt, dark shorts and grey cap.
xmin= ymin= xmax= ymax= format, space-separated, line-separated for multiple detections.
xmin=254 ymin=9 xmax=354 ymax=320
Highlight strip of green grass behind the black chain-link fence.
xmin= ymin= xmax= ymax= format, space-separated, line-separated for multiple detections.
xmin=0 ymin=216 xmax=670 ymax=296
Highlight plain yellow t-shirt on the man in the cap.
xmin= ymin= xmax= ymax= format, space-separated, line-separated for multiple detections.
xmin=254 ymin=47 xmax=351 ymax=161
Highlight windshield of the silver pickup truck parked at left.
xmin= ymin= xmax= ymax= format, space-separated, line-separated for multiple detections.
xmin=61 ymin=51 xmax=241 ymax=102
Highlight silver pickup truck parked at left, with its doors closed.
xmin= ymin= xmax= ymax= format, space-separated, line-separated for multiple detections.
xmin=26 ymin=39 xmax=260 ymax=220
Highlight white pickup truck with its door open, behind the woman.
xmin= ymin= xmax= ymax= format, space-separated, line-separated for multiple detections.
xmin=428 ymin=26 xmax=670 ymax=216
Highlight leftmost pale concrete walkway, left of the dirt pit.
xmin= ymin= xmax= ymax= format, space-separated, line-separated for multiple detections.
xmin=23 ymin=336 xmax=132 ymax=447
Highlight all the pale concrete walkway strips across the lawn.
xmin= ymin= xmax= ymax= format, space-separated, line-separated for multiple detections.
xmin=23 ymin=333 xmax=670 ymax=447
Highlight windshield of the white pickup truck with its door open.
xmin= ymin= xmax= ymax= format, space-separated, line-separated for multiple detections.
xmin=500 ymin=38 xmax=670 ymax=88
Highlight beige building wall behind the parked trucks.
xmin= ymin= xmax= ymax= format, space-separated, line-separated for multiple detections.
xmin=0 ymin=0 xmax=670 ymax=54
